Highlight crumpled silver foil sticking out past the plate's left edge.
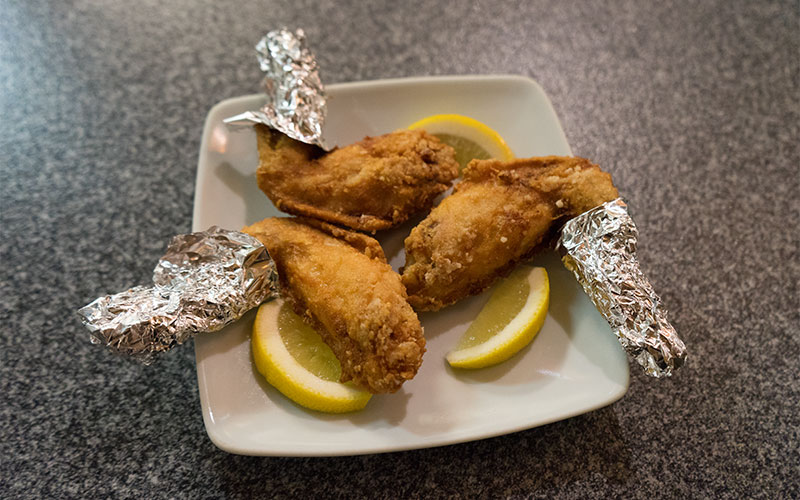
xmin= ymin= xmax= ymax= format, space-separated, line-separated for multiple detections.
xmin=78 ymin=226 xmax=278 ymax=364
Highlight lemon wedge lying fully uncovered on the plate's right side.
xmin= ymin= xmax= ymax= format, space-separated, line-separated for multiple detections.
xmin=446 ymin=265 xmax=550 ymax=368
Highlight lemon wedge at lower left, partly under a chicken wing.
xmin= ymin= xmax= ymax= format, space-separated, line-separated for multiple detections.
xmin=251 ymin=300 xmax=372 ymax=413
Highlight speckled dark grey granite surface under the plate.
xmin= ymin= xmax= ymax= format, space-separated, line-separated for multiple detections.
xmin=0 ymin=0 xmax=800 ymax=498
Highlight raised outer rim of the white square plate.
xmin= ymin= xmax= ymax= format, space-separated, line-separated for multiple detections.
xmin=192 ymin=74 xmax=630 ymax=457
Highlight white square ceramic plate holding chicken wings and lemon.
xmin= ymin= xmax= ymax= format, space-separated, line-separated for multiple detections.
xmin=193 ymin=76 xmax=629 ymax=456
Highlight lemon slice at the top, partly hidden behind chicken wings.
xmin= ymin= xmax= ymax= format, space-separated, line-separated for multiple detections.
xmin=408 ymin=114 xmax=514 ymax=168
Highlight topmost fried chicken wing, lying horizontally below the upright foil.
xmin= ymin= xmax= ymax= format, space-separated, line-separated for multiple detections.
xmin=256 ymin=125 xmax=458 ymax=231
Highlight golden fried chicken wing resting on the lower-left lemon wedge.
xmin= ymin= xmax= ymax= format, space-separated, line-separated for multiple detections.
xmin=243 ymin=218 xmax=425 ymax=393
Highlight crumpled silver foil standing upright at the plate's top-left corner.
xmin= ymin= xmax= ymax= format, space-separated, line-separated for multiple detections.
xmin=224 ymin=28 xmax=330 ymax=150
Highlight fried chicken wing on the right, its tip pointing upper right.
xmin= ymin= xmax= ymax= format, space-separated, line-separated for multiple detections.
xmin=402 ymin=156 xmax=618 ymax=311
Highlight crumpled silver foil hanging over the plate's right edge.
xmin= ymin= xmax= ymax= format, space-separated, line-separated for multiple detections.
xmin=556 ymin=198 xmax=686 ymax=378
